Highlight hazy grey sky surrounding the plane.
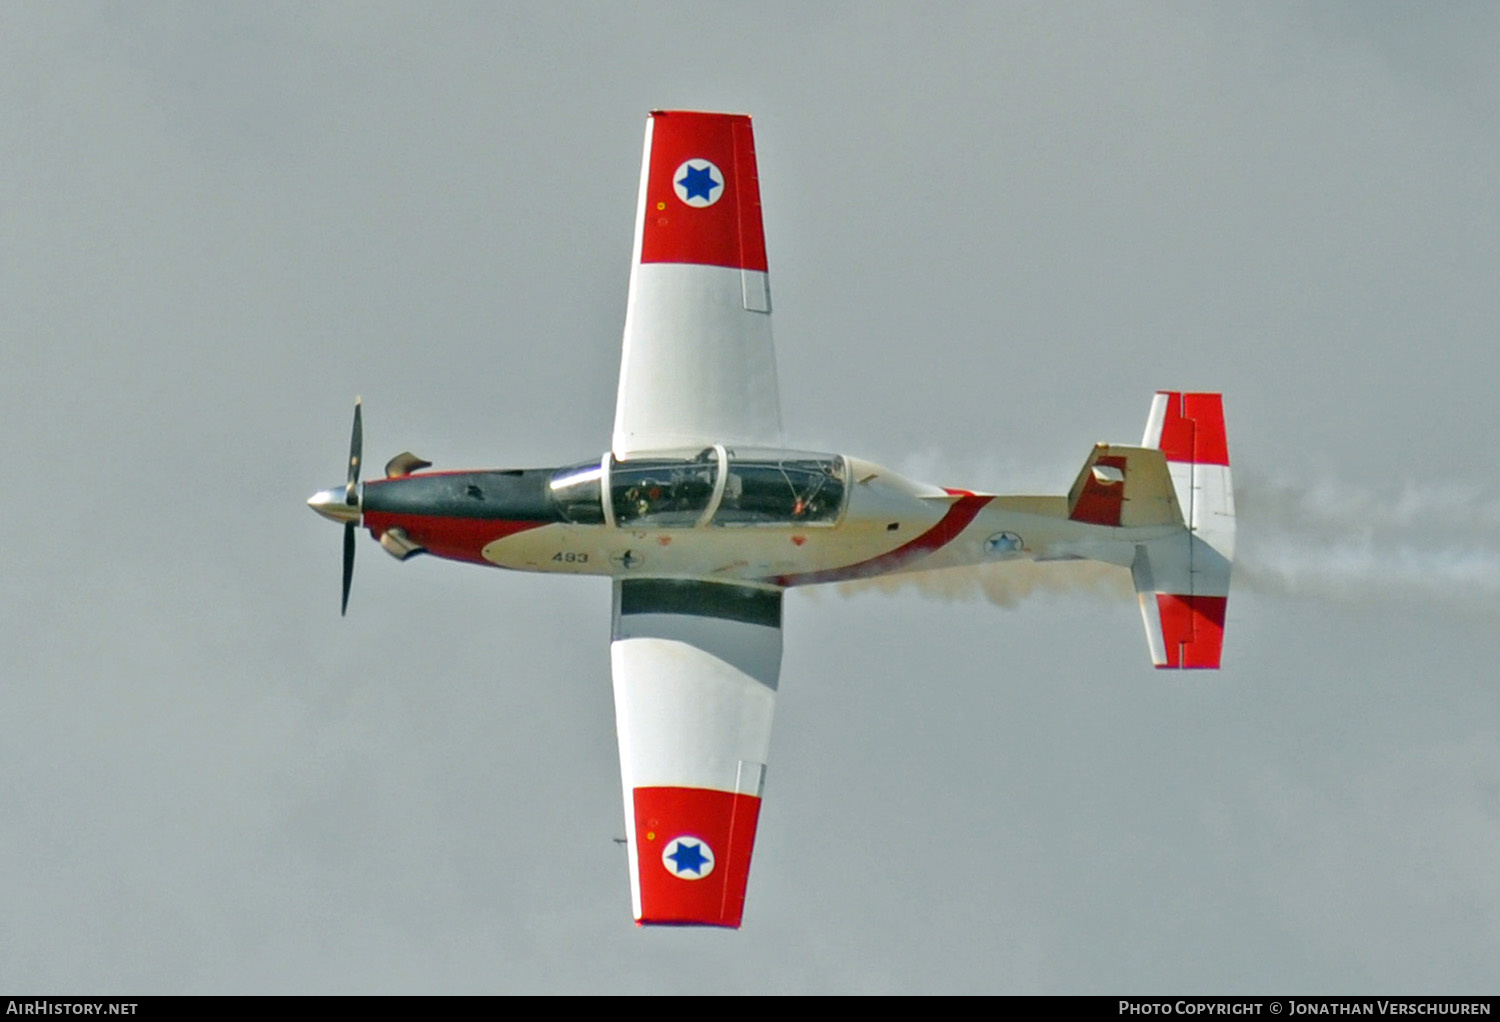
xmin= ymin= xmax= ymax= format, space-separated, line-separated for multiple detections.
xmin=0 ymin=3 xmax=1500 ymax=993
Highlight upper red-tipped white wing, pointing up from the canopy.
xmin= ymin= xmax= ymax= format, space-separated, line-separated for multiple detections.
xmin=612 ymin=111 xmax=782 ymax=459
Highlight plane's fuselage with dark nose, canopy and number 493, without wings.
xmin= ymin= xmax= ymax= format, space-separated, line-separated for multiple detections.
xmin=345 ymin=446 xmax=1176 ymax=587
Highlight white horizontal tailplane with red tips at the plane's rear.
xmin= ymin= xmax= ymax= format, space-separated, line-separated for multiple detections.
xmin=1131 ymin=390 xmax=1235 ymax=668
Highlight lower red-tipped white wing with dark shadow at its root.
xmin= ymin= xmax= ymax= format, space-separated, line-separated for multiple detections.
xmin=611 ymin=579 xmax=782 ymax=927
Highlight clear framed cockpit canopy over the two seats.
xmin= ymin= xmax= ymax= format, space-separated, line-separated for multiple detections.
xmin=549 ymin=446 xmax=849 ymax=528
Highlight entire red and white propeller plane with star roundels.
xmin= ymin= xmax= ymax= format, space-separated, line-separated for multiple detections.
xmin=308 ymin=111 xmax=1235 ymax=926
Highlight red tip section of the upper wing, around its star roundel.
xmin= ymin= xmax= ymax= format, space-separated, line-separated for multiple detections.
xmin=641 ymin=111 xmax=767 ymax=273
